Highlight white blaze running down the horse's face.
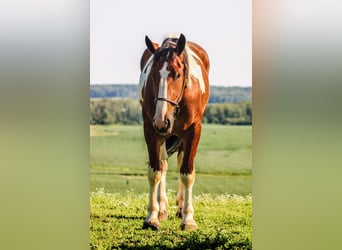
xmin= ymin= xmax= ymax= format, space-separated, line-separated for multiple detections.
xmin=154 ymin=62 xmax=170 ymax=128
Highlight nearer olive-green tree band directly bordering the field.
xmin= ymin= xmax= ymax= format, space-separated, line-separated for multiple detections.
xmin=90 ymin=98 xmax=252 ymax=125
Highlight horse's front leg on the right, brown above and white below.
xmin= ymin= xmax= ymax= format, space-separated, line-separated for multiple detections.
xmin=180 ymin=124 xmax=201 ymax=231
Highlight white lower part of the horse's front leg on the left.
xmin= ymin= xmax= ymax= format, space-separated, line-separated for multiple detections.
xmin=144 ymin=167 xmax=161 ymax=228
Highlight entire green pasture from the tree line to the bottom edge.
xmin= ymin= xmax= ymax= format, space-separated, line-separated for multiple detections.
xmin=90 ymin=124 xmax=252 ymax=249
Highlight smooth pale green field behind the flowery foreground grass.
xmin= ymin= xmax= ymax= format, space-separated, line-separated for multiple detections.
xmin=90 ymin=124 xmax=252 ymax=195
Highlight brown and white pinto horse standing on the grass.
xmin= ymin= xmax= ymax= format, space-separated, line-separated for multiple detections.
xmin=139 ymin=34 xmax=209 ymax=230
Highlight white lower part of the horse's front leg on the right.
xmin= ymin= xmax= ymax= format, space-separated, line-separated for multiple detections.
xmin=180 ymin=171 xmax=197 ymax=230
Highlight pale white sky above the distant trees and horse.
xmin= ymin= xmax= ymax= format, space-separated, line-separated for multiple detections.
xmin=90 ymin=0 xmax=252 ymax=87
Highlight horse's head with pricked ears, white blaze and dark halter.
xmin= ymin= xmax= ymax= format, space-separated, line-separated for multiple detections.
xmin=146 ymin=35 xmax=185 ymax=135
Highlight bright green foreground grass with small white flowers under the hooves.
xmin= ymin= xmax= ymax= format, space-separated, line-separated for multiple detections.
xmin=90 ymin=189 xmax=252 ymax=249
